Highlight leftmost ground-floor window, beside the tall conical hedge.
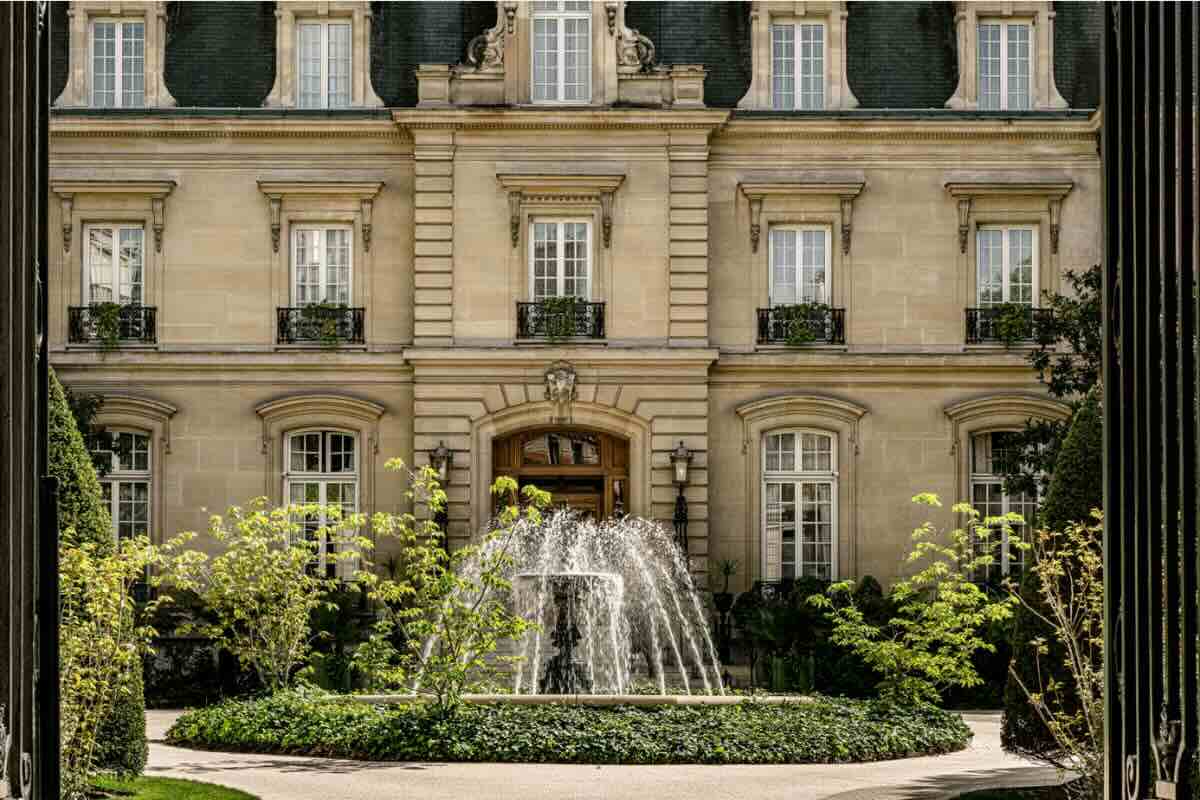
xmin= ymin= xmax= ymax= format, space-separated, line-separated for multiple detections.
xmin=92 ymin=431 xmax=150 ymax=540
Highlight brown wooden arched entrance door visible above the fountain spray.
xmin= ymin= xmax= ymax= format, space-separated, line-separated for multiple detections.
xmin=492 ymin=425 xmax=629 ymax=519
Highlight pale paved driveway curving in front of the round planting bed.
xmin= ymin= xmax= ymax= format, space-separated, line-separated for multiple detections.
xmin=146 ymin=711 xmax=1057 ymax=800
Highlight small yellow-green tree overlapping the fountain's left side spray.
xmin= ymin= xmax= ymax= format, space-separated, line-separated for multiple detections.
xmin=355 ymin=459 xmax=550 ymax=715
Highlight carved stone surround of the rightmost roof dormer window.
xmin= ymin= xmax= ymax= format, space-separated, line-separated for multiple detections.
xmin=946 ymin=0 xmax=1067 ymax=110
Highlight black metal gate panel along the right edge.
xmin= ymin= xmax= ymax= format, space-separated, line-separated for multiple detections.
xmin=1102 ymin=2 xmax=1200 ymax=800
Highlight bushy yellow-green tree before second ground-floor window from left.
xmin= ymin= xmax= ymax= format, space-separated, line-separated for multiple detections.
xmin=172 ymin=498 xmax=371 ymax=691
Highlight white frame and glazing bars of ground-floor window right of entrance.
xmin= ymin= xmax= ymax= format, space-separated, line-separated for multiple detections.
xmin=758 ymin=428 xmax=839 ymax=581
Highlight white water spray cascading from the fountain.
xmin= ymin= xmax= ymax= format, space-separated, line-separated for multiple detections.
xmin=491 ymin=511 xmax=724 ymax=694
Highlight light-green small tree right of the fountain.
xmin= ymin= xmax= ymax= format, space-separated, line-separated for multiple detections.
xmin=809 ymin=494 xmax=1019 ymax=704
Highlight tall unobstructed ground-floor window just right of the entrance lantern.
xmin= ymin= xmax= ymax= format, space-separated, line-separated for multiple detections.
xmin=763 ymin=431 xmax=838 ymax=581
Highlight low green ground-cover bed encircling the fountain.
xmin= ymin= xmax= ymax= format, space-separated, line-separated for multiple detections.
xmin=167 ymin=692 xmax=971 ymax=764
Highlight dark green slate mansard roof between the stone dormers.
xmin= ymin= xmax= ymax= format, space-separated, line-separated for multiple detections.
xmin=50 ymin=0 xmax=1103 ymax=113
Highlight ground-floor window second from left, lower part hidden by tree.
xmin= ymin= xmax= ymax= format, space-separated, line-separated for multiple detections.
xmin=283 ymin=431 xmax=359 ymax=578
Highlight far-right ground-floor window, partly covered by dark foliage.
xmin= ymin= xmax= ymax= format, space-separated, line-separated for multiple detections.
xmin=971 ymin=431 xmax=1038 ymax=581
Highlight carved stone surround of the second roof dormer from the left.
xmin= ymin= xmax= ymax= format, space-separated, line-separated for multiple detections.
xmin=263 ymin=0 xmax=383 ymax=108
